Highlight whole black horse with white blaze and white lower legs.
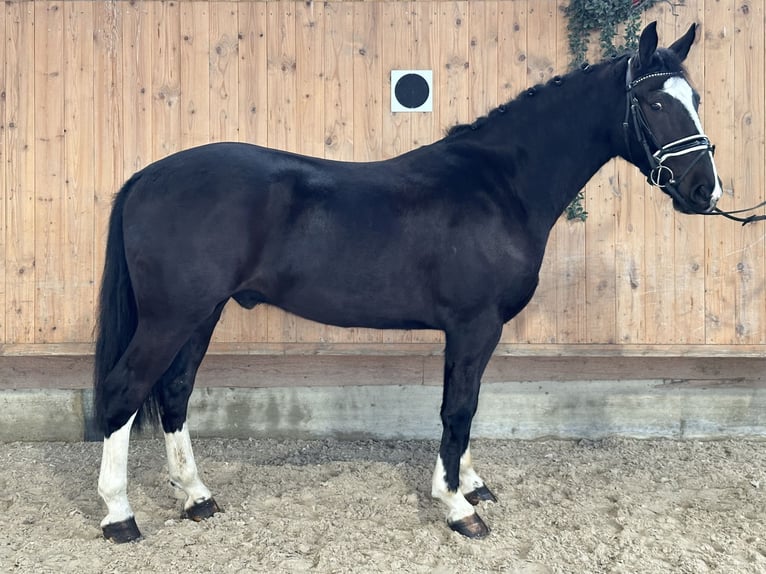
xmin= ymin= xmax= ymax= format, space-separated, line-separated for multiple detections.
xmin=95 ymin=24 xmax=721 ymax=542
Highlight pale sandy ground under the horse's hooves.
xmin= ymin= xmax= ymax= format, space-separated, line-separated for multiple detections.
xmin=0 ymin=439 xmax=766 ymax=574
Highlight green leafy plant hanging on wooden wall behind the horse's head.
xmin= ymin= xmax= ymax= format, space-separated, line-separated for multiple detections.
xmin=564 ymin=0 xmax=657 ymax=221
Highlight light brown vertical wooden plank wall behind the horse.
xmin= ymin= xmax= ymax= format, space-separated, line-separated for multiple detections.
xmin=0 ymin=0 xmax=766 ymax=356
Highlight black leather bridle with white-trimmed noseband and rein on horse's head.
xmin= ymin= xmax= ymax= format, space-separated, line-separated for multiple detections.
xmin=622 ymin=58 xmax=766 ymax=225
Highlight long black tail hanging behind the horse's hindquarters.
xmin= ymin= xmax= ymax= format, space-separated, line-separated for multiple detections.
xmin=93 ymin=174 xmax=159 ymax=435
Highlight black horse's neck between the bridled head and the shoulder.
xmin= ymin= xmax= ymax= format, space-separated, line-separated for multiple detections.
xmin=468 ymin=61 xmax=625 ymax=232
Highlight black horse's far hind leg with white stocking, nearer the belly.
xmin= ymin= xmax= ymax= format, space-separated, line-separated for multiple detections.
xmin=159 ymin=303 xmax=224 ymax=522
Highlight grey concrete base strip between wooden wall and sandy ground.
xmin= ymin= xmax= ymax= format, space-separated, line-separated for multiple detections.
xmin=0 ymin=379 xmax=766 ymax=441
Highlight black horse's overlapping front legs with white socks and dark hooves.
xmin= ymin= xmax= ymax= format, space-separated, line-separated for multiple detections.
xmin=431 ymin=320 xmax=502 ymax=538
